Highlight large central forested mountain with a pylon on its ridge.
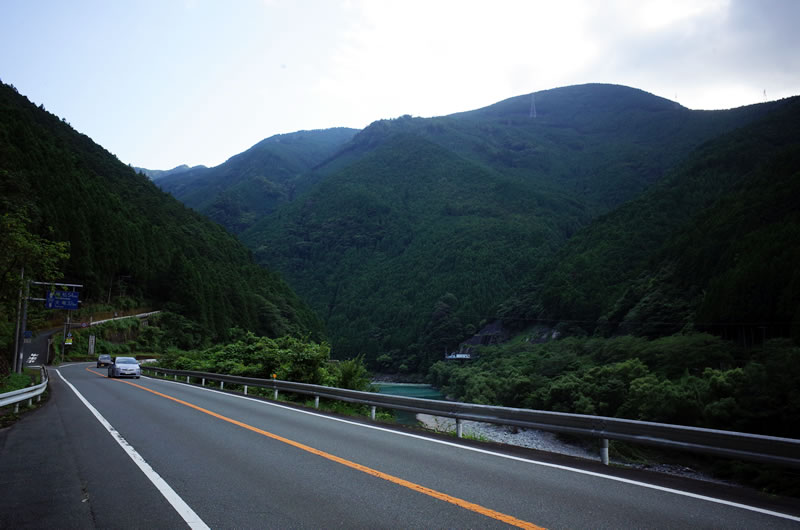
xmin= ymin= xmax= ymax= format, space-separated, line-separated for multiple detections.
xmin=236 ymin=85 xmax=777 ymax=371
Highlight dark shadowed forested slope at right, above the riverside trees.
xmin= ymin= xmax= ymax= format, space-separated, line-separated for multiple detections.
xmin=504 ymin=98 xmax=800 ymax=341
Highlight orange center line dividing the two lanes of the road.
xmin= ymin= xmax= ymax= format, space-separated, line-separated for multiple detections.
xmin=86 ymin=367 xmax=544 ymax=530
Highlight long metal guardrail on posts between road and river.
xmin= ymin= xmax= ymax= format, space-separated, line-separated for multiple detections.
xmin=142 ymin=366 xmax=800 ymax=468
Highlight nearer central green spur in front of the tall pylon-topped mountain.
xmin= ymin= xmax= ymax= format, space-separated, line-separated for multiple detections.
xmin=243 ymin=135 xmax=585 ymax=368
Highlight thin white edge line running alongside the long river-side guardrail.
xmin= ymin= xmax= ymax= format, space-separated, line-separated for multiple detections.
xmin=148 ymin=376 xmax=800 ymax=522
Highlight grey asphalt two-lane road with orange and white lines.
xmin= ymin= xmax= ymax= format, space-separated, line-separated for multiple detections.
xmin=0 ymin=363 xmax=800 ymax=529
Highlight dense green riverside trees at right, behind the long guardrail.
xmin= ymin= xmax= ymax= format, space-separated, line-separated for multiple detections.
xmin=429 ymin=331 xmax=800 ymax=438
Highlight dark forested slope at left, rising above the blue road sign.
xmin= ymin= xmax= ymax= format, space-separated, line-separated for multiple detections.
xmin=0 ymin=84 xmax=321 ymax=364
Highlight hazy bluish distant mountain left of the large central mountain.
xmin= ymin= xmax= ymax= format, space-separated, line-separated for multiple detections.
xmin=154 ymin=128 xmax=356 ymax=233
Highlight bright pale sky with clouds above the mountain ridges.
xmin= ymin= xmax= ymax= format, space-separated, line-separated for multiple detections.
xmin=0 ymin=0 xmax=800 ymax=169
